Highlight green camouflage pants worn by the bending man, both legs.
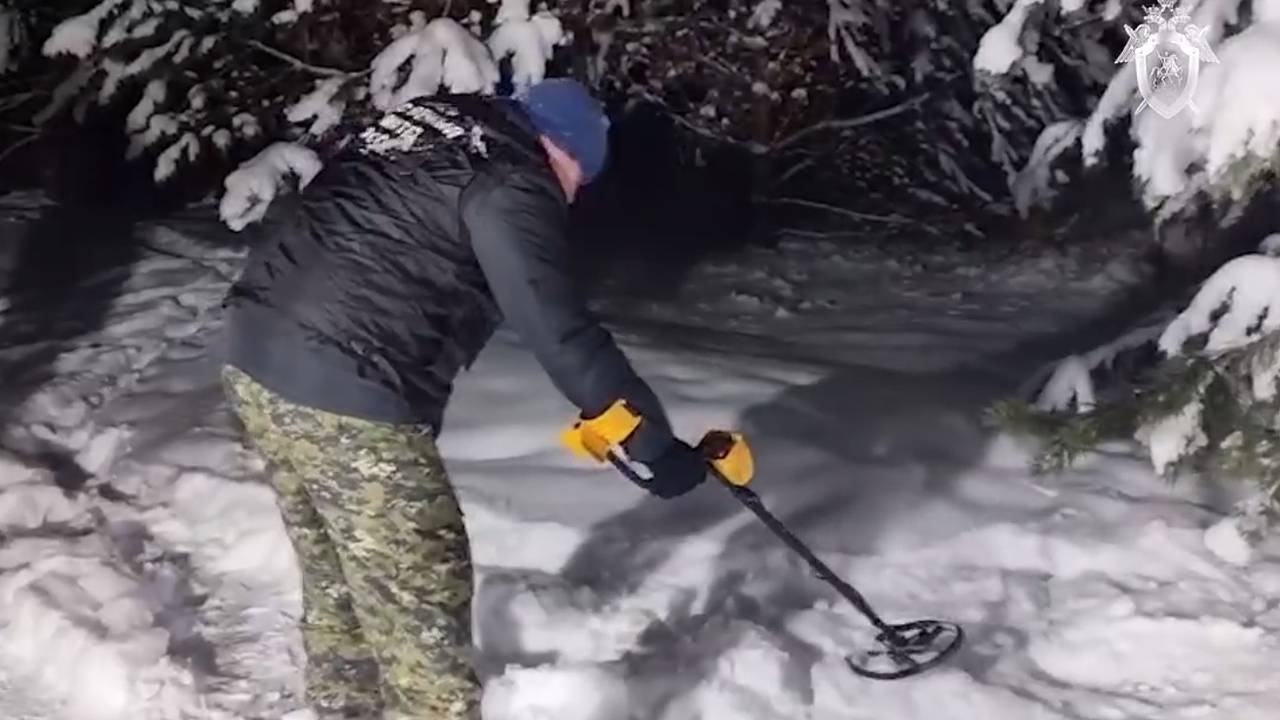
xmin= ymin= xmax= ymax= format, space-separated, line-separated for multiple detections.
xmin=223 ymin=368 xmax=480 ymax=720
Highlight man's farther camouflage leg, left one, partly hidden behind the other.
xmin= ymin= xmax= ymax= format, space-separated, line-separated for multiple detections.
xmin=224 ymin=369 xmax=381 ymax=720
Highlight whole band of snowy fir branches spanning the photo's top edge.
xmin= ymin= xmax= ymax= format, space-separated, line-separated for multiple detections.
xmin=0 ymin=0 xmax=1280 ymax=233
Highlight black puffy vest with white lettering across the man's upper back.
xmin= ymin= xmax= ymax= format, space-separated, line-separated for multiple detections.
xmin=227 ymin=91 xmax=554 ymax=429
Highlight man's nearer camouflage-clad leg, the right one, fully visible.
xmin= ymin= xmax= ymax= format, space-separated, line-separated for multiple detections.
xmin=280 ymin=414 xmax=480 ymax=720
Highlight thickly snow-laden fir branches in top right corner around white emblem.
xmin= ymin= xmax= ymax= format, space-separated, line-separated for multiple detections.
xmin=973 ymin=0 xmax=1280 ymax=229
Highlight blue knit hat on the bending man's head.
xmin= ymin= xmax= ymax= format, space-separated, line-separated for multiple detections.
xmin=517 ymin=78 xmax=609 ymax=184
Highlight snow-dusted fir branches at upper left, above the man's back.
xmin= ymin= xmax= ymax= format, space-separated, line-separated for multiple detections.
xmin=23 ymin=0 xmax=564 ymax=188
